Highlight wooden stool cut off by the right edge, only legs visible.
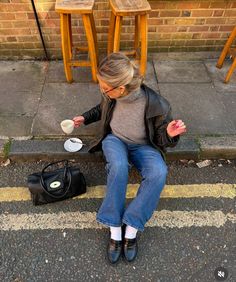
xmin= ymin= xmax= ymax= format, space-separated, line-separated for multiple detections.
xmin=216 ymin=26 xmax=236 ymax=83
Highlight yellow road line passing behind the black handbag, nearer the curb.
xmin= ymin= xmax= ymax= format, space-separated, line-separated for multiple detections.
xmin=0 ymin=183 xmax=236 ymax=202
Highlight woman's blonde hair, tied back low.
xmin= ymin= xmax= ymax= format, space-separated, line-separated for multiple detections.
xmin=97 ymin=53 xmax=143 ymax=93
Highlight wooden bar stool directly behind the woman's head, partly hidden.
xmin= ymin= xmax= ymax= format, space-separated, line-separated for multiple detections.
xmin=108 ymin=0 xmax=151 ymax=76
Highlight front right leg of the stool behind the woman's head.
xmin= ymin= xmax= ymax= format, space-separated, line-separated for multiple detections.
xmin=140 ymin=15 xmax=147 ymax=76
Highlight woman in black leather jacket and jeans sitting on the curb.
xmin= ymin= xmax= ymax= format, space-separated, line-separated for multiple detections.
xmin=73 ymin=53 xmax=186 ymax=264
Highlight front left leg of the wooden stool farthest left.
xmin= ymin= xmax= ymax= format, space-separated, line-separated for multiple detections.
xmin=60 ymin=14 xmax=73 ymax=82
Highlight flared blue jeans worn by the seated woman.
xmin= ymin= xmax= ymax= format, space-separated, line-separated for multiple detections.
xmin=97 ymin=134 xmax=167 ymax=231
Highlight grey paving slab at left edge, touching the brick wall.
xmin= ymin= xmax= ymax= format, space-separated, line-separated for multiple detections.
xmin=0 ymin=61 xmax=46 ymax=116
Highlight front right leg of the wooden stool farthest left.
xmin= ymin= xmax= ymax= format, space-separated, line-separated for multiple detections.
xmin=83 ymin=14 xmax=97 ymax=82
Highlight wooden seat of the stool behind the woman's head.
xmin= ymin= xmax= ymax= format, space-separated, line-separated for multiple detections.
xmin=110 ymin=0 xmax=151 ymax=16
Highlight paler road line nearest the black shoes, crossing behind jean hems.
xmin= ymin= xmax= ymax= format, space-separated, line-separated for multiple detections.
xmin=0 ymin=210 xmax=236 ymax=231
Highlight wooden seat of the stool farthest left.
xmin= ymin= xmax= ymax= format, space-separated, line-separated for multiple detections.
xmin=55 ymin=0 xmax=95 ymax=14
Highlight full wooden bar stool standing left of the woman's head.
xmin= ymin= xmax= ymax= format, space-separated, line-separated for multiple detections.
xmin=55 ymin=0 xmax=98 ymax=82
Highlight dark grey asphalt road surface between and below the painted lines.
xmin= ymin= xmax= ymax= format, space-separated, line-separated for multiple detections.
xmin=0 ymin=160 xmax=236 ymax=282
